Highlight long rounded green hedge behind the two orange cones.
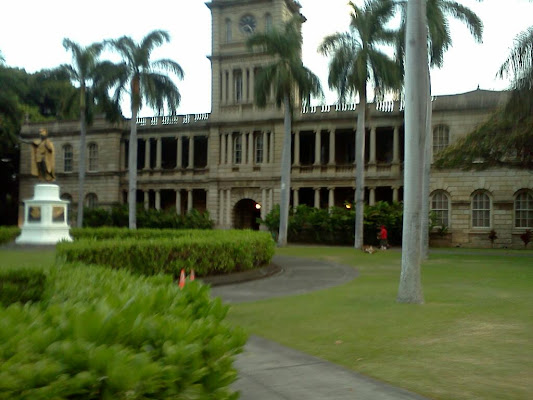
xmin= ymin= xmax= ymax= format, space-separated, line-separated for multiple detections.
xmin=56 ymin=229 xmax=275 ymax=278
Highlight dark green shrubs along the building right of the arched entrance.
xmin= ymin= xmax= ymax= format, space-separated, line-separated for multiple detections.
xmin=260 ymin=202 xmax=402 ymax=245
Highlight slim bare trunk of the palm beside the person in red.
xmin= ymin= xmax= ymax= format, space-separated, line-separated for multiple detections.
xmin=354 ymin=87 xmax=366 ymax=249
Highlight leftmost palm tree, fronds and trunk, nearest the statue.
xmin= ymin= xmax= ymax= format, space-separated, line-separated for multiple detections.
xmin=63 ymin=39 xmax=111 ymax=228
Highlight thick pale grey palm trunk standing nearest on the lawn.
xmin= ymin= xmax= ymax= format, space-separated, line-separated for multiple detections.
xmin=398 ymin=0 xmax=428 ymax=303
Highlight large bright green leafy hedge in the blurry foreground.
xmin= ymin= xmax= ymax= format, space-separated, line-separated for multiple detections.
xmin=0 ymin=265 xmax=246 ymax=400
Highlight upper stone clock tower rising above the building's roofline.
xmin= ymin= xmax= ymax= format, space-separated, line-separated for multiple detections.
xmin=206 ymin=0 xmax=301 ymax=117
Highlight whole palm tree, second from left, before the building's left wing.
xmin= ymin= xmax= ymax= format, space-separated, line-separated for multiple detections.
xmin=108 ymin=30 xmax=184 ymax=229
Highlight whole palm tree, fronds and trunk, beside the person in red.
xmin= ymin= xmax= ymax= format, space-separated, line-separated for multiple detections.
xmin=318 ymin=0 xmax=401 ymax=249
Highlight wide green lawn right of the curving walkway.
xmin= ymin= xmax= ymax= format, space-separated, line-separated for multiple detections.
xmin=230 ymin=247 xmax=533 ymax=400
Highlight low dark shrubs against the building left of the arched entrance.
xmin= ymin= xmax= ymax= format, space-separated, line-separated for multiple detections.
xmin=83 ymin=205 xmax=214 ymax=229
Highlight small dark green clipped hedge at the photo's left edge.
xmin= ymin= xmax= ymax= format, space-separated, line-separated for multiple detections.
xmin=0 ymin=268 xmax=46 ymax=307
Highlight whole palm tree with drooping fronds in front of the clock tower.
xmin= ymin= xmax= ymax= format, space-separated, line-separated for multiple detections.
xmin=246 ymin=16 xmax=322 ymax=247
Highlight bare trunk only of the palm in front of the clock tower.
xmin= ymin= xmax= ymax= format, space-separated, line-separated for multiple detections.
xmin=278 ymin=94 xmax=292 ymax=247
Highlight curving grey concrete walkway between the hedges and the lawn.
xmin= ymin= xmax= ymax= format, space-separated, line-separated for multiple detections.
xmin=211 ymin=256 xmax=424 ymax=400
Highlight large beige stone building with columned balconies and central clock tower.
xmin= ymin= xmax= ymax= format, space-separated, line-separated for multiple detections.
xmin=20 ymin=0 xmax=533 ymax=247
